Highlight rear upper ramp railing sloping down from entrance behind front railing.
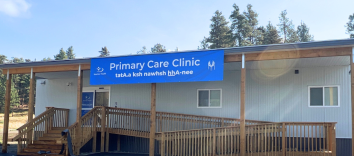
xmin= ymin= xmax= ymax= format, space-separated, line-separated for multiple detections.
xmin=68 ymin=106 xmax=269 ymax=154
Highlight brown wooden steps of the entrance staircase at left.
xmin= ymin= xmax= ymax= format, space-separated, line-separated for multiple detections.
xmin=17 ymin=127 xmax=66 ymax=156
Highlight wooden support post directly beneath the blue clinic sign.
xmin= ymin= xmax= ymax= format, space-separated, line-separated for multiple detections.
xmin=149 ymin=83 xmax=156 ymax=156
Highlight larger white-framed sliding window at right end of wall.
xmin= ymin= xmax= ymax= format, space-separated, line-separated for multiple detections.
xmin=309 ymin=86 xmax=339 ymax=107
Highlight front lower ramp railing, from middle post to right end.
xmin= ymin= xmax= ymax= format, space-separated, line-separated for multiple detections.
xmin=156 ymin=122 xmax=336 ymax=156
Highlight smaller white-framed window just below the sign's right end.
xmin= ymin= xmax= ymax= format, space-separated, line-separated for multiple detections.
xmin=198 ymin=89 xmax=221 ymax=108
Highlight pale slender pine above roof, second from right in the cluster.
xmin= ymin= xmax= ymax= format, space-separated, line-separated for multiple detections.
xmin=278 ymin=10 xmax=299 ymax=43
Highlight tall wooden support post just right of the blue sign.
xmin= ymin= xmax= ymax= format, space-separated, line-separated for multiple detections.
xmin=240 ymin=54 xmax=246 ymax=156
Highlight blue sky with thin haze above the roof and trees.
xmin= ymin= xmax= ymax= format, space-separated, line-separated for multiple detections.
xmin=0 ymin=0 xmax=354 ymax=61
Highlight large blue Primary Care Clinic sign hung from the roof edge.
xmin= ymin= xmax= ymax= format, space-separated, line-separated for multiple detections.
xmin=90 ymin=50 xmax=224 ymax=85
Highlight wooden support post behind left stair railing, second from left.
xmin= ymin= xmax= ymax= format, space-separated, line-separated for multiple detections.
xmin=27 ymin=68 xmax=36 ymax=144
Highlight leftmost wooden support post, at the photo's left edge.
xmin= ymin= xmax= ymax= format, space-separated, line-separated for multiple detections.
xmin=2 ymin=70 xmax=12 ymax=153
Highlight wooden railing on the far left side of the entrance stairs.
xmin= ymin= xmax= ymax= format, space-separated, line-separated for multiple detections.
xmin=12 ymin=107 xmax=69 ymax=152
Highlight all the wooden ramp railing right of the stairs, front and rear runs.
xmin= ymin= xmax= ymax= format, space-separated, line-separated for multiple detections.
xmin=64 ymin=107 xmax=336 ymax=156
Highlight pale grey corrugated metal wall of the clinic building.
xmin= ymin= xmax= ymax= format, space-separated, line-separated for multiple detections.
xmin=36 ymin=66 xmax=351 ymax=138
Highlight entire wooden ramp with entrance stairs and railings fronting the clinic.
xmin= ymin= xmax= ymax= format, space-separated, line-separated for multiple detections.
xmin=14 ymin=107 xmax=336 ymax=156
